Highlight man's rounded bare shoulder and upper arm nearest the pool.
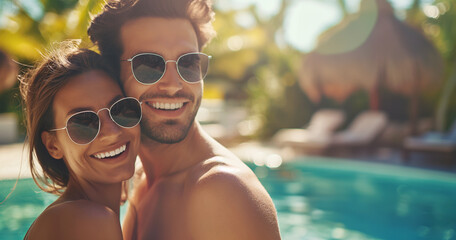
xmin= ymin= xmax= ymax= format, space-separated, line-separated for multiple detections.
xmin=187 ymin=166 xmax=280 ymax=240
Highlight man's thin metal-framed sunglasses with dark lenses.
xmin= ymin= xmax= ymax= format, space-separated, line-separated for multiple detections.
xmin=121 ymin=52 xmax=212 ymax=85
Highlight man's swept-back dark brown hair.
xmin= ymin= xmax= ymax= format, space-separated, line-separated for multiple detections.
xmin=87 ymin=0 xmax=215 ymax=74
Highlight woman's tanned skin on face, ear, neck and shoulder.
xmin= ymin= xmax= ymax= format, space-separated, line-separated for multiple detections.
xmin=25 ymin=70 xmax=140 ymax=240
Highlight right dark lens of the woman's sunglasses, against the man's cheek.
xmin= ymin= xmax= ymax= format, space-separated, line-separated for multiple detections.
xmin=110 ymin=98 xmax=141 ymax=128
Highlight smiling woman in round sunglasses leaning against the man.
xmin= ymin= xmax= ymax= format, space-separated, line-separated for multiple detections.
xmin=20 ymin=43 xmax=141 ymax=240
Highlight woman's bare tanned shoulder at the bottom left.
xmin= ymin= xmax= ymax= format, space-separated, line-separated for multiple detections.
xmin=27 ymin=200 xmax=122 ymax=239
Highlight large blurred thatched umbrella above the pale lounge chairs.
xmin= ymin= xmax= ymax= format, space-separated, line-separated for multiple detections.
xmin=300 ymin=0 xmax=443 ymax=133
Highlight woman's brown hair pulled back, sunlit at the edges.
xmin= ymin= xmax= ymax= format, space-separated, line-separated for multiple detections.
xmin=20 ymin=41 xmax=116 ymax=194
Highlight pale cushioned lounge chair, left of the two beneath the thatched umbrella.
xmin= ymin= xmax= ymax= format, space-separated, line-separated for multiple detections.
xmin=272 ymin=109 xmax=345 ymax=153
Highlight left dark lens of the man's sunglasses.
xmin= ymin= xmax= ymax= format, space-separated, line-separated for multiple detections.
xmin=132 ymin=54 xmax=165 ymax=84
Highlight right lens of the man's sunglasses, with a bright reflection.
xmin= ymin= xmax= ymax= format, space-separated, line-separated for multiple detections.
xmin=177 ymin=53 xmax=209 ymax=83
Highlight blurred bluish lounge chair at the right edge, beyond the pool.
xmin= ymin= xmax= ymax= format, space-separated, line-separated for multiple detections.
xmin=402 ymin=120 xmax=456 ymax=160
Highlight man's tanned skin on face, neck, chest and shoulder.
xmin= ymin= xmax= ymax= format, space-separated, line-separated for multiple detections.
xmin=120 ymin=17 xmax=280 ymax=240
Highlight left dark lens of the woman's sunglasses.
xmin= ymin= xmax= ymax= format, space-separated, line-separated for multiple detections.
xmin=67 ymin=112 xmax=100 ymax=144
